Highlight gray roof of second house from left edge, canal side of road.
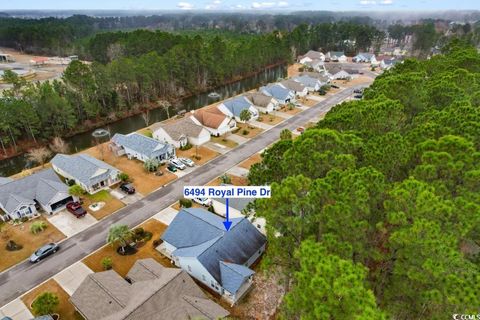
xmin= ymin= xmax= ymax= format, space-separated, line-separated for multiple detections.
xmin=51 ymin=153 xmax=120 ymax=186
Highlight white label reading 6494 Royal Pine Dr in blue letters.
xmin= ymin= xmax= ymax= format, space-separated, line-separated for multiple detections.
xmin=183 ymin=186 xmax=272 ymax=199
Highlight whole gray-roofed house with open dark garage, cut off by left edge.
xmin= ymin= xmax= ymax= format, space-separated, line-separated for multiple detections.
xmin=0 ymin=169 xmax=74 ymax=220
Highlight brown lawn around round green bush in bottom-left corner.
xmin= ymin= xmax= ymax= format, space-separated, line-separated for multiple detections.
xmin=21 ymin=279 xmax=83 ymax=320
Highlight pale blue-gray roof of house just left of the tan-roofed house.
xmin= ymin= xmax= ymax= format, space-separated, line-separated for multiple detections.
xmin=112 ymin=132 xmax=173 ymax=158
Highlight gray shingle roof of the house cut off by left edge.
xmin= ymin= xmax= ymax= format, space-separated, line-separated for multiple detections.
xmin=0 ymin=169 xmax=68 ymax=212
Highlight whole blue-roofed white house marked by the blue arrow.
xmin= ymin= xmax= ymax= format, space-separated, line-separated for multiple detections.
xmin=157 ymin=208 xmax=267 ymax=304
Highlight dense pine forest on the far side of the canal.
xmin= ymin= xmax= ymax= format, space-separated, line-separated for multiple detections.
xmin=0 ymin=22 xmax=384 ymax=154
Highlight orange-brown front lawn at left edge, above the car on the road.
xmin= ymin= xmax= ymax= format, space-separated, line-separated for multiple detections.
xmin=0 ymin=217 xmax=65 ymax=271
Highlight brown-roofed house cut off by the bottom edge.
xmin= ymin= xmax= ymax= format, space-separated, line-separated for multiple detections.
xmin=70 ymin=258 xmax=229 ymax=320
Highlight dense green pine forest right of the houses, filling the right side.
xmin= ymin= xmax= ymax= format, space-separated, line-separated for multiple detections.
xmin=249 ymin=41 xmax=480 ymax=320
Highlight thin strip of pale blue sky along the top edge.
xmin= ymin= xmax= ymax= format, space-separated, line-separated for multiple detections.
xmin=0 ymin=0 xmax=480 ymax=11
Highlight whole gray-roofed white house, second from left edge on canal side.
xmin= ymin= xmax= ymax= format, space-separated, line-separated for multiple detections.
xmin=50 ymin=154 xmax=120 ymax=194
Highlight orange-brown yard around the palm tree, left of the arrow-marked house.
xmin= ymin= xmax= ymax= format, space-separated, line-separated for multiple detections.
xmin=83 ymin=219 xmax=172 ymax=277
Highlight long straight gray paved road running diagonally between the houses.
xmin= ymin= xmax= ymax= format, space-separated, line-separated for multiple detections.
xmin=0 ymin=86 xmax=363 ymax=306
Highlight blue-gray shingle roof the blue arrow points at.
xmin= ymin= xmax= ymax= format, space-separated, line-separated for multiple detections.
xmin=162 ymin=208 xmax=267 ymax=292
